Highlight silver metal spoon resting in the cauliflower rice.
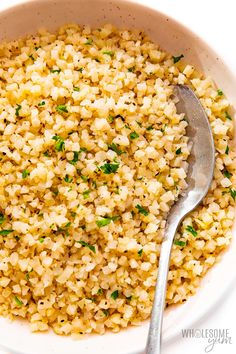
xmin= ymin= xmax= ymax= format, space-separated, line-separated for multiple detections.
xmin=146 ymin=85 xmax=215 ymax=354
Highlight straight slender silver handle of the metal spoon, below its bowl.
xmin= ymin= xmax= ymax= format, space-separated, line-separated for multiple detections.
xmin=146 ymin=220 xmax=180 ymax=354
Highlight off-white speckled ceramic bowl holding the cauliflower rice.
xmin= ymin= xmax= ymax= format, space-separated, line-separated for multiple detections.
xmin=0 ymin=0 xmax=236 ymax=354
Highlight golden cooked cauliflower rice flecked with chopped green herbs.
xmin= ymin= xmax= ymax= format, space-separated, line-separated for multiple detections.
xmin=0 ymin=25 xmax=236 ymax=335
